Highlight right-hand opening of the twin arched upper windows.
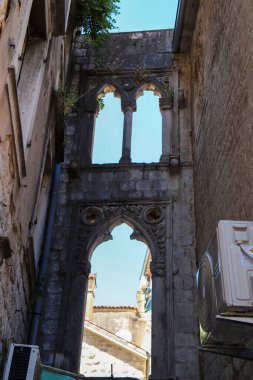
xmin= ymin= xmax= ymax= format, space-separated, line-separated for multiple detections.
xmin=131 ymin=89 xmax=162 ymax=163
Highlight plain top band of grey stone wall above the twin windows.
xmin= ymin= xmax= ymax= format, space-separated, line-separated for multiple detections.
xmin=74 ymin=29 xmax=173 ymax=70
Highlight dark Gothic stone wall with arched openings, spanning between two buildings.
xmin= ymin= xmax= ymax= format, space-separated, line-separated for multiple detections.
xmin=39 ymin=31 xmax=199 ymax=380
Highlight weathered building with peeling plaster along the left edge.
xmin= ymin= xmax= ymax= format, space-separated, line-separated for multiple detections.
xmin=0 ymin=0 xmax=73 ymax=374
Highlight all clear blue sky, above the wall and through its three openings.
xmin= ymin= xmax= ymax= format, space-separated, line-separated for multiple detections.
xmin=91 ymin=0 xmax=178 ymax=306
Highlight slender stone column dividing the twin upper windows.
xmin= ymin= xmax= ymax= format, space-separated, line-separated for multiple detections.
xmin=119 ymin=102 xmax=136 ymax=164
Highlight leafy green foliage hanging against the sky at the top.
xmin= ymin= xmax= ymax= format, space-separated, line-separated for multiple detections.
xmin=77 ymin=0 xmax=120 ymax=43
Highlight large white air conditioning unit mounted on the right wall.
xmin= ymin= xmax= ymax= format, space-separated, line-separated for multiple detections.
xmin=198 ymin=220 xmax=253 ymax=346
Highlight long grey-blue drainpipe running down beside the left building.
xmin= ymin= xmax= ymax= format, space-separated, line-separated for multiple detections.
xmin=29 ymin=164 xmax=61 ymax=345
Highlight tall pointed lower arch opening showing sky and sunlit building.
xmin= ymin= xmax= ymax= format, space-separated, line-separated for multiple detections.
xmin=80 ymin=224 xmax=152 ymax=378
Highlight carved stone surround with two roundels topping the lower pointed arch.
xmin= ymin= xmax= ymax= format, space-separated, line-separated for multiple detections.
xmin=76 ymin=204 xmax=166 ymax=261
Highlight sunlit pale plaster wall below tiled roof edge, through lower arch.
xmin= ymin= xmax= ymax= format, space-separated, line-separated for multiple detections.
xmin=80 ymin=306 xmax=151 ymax=378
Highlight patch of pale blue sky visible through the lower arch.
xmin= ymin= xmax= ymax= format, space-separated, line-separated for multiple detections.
xmin=91 ymin=224 xmax=147 ymax=306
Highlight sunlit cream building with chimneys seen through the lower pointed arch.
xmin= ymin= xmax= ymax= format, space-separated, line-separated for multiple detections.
xmin=80 ymin=270 xmax=151 ymax=379
